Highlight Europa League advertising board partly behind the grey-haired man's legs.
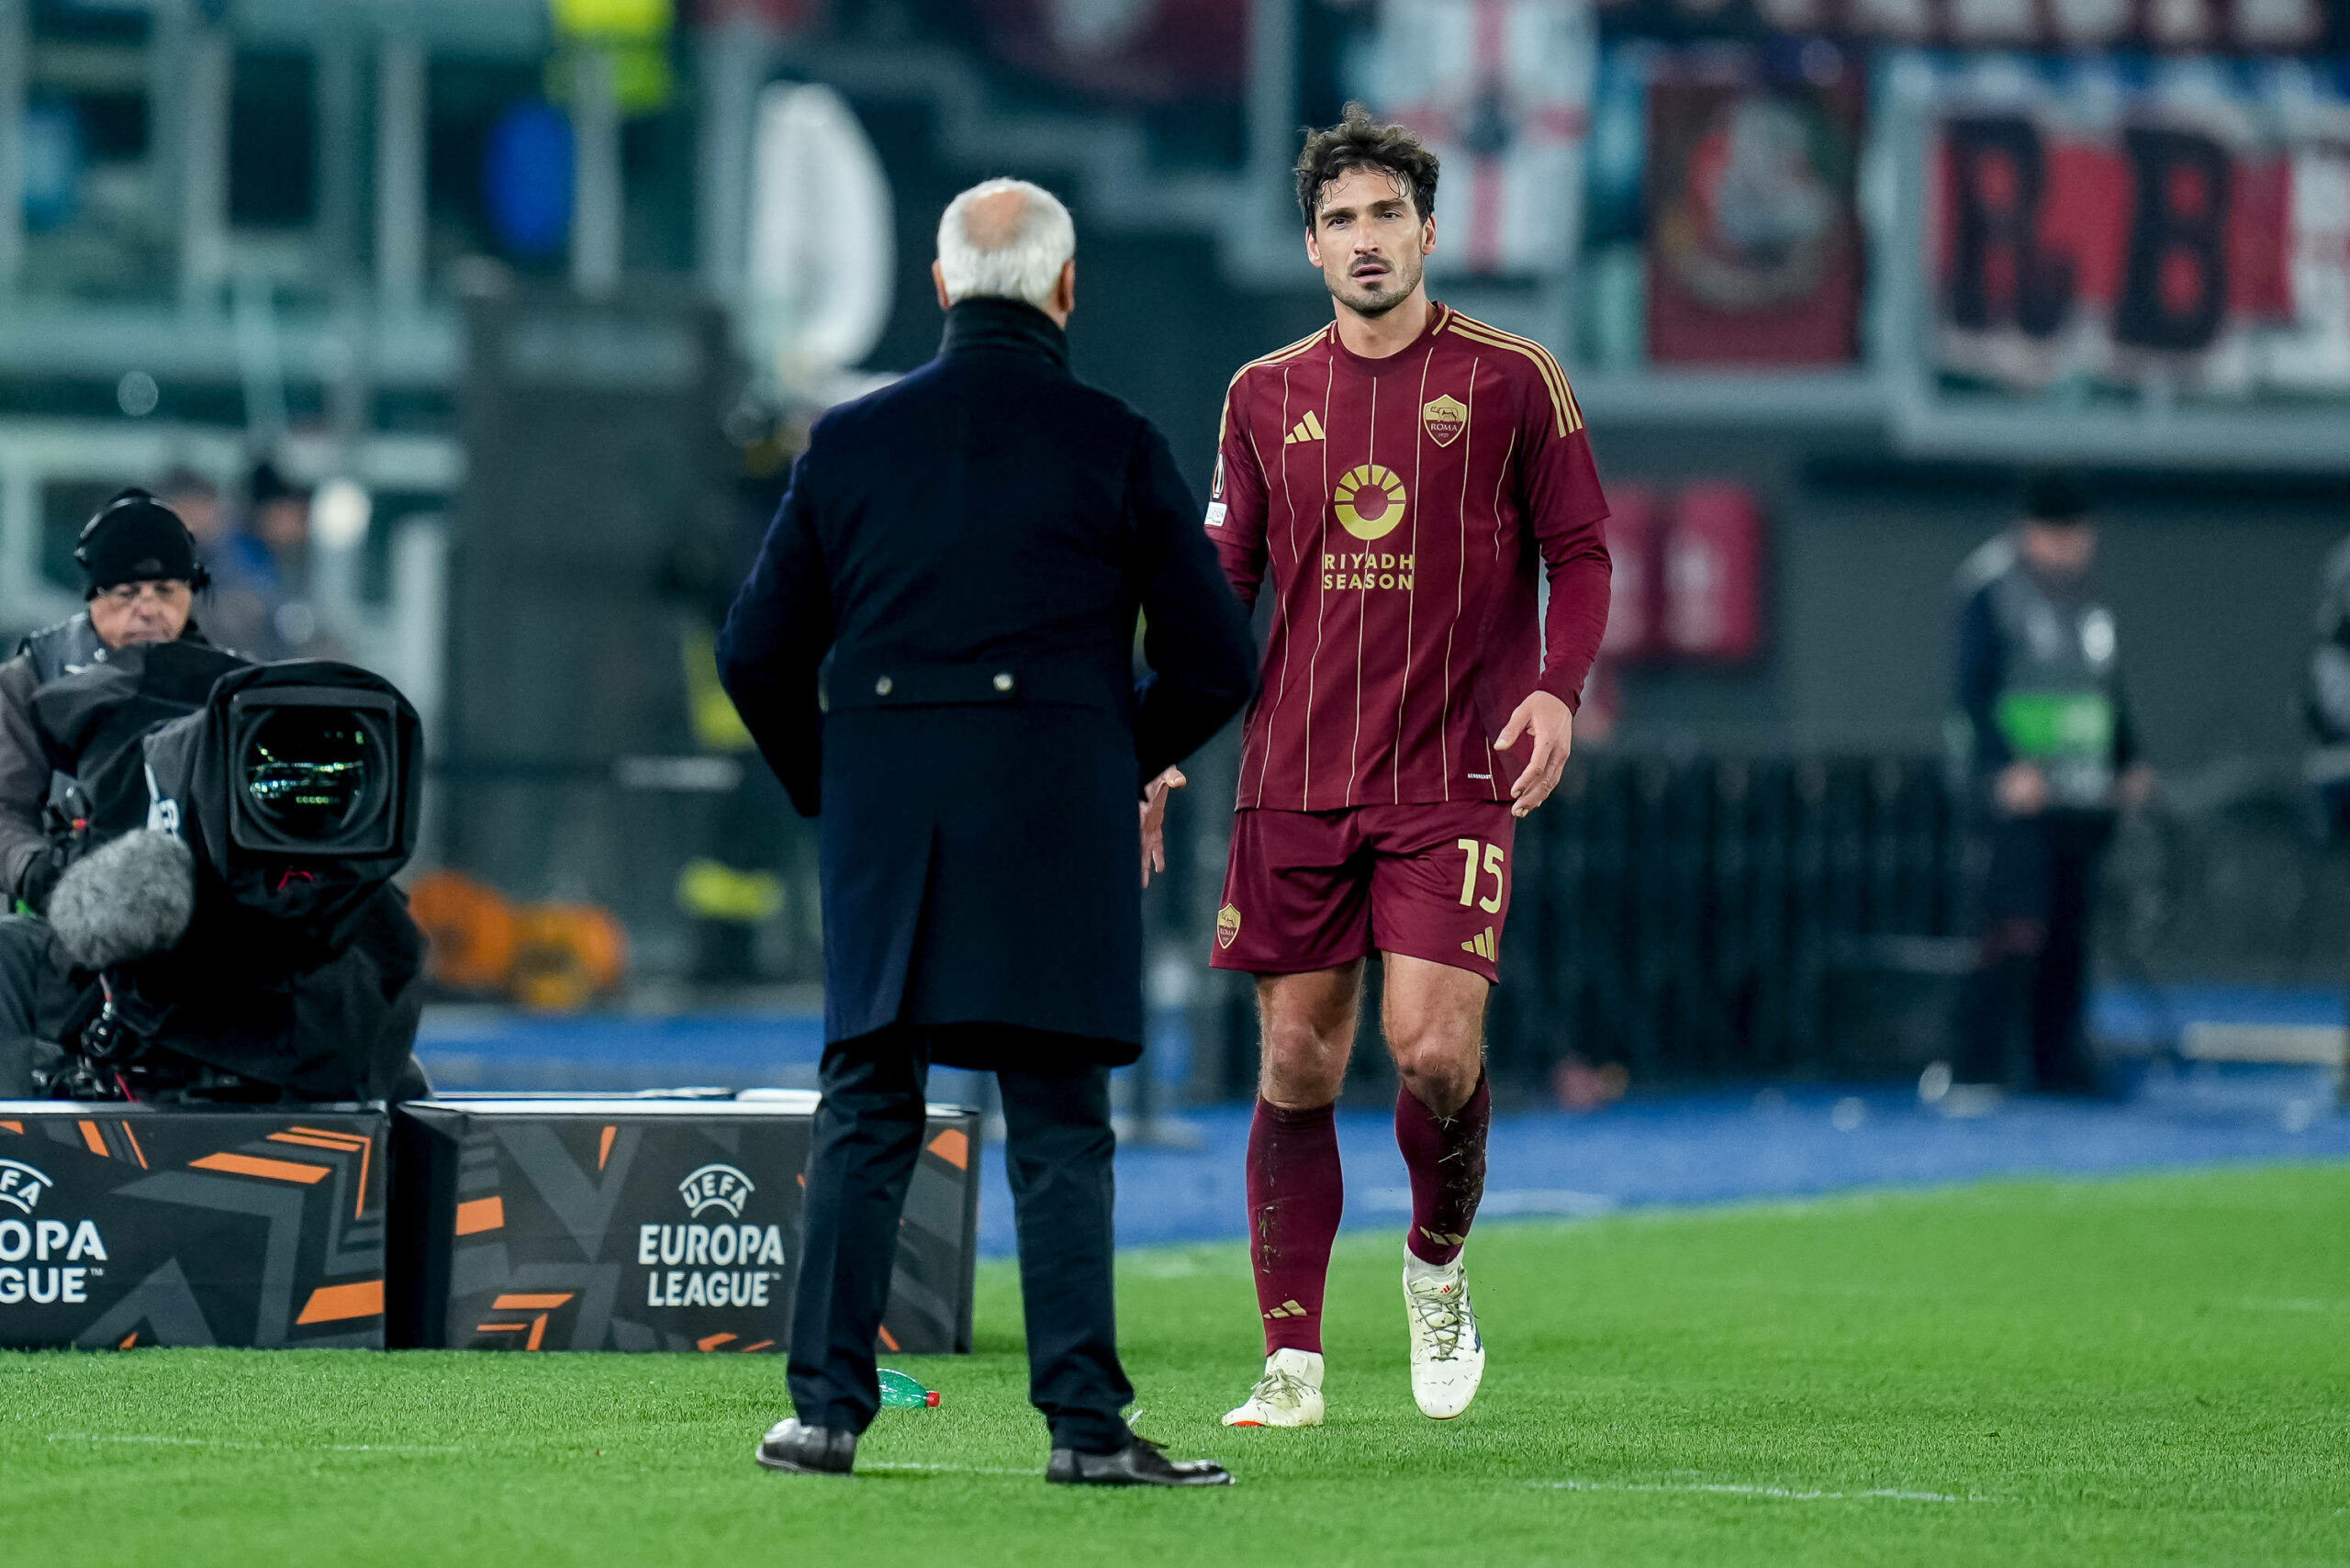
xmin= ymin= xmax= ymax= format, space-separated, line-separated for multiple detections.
xmin=390 ymin=1091 xmax=980 ymax=1354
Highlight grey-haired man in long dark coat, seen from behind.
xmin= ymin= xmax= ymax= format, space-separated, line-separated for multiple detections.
xmin=719 ymin=181 xmax=1255 ymax=1485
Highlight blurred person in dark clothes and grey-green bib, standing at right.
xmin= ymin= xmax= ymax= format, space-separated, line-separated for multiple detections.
xmin=1957 ymin=475 xmax=2153 ymax=1105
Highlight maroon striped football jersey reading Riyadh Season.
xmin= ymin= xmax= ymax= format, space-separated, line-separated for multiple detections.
xmin=1208 ymin=306 xmax=1607 ymax=811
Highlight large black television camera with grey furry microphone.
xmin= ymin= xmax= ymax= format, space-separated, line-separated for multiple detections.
xmin=35 ymin=644 xmax=428 ymax=1100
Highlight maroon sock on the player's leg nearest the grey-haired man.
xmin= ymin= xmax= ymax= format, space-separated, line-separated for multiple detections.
xmin=1248 ymin=1100 xmax=1347 ymax=1354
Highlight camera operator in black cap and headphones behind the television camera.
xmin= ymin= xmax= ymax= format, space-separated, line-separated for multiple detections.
xmin=0 ymin=489 xmax=218 ymax=1095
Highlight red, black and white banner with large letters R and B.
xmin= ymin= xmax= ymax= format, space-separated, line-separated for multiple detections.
xmin=1887 ymin=54 xmax=2350 ymax=404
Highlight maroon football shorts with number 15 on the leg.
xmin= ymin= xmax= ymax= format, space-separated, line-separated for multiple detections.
xmin=1208 ymin=800 xmax=1518 ymax=980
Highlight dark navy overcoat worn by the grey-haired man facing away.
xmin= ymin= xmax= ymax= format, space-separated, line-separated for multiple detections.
xmin=719 ymin=298 xmax=1258 ymax=1068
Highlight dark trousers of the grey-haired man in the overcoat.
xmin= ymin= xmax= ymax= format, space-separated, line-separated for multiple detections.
xmin=789 ymin=1027 xmax=1135 ymax=1453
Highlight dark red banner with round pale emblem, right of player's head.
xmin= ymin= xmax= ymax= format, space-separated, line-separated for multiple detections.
xmin=1645 ymin=42 xmax=1868 ymax=364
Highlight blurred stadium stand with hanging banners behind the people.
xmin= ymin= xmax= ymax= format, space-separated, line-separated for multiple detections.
xmin=0 ymin=0 xmax=2350 ymax=1098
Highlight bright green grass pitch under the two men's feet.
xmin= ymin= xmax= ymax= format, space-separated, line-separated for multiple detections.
xmin=0 ymin=1166 xmax=2350 ymax=1568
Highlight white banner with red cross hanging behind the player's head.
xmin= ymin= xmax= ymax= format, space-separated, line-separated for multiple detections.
xmin=1363 ymin=0 xmax=1598 ymax=277
